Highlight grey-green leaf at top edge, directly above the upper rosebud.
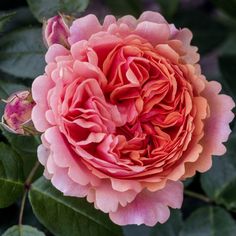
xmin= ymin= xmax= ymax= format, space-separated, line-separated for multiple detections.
xmin=27 ymin=0 xmax=89 ymax=22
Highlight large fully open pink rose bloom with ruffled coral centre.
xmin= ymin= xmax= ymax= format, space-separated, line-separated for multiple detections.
xmin=32 ymin=12 xmax=234 ymax=226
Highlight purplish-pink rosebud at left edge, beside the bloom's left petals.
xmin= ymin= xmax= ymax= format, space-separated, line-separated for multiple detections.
xmin=2 ymin=91 xmax=36 ymax=135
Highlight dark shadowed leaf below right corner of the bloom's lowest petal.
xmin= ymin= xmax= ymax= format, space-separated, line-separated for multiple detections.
xmin=150 ymin=210 xmax=183 ymax=236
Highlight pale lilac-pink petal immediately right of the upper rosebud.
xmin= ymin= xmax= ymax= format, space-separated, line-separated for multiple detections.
xmin=69 ymin=14 xmax=102 ymax=45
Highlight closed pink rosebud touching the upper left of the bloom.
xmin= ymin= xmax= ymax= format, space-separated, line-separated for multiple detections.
xmin=43 ymin=14 xmax=73 ymax=48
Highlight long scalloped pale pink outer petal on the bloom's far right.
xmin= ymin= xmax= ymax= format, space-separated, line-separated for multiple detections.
xmin=184 ymin=81 xmax=235 ymax=177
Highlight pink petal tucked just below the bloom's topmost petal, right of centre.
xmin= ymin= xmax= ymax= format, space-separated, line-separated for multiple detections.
xmin=134 ymin=21 xmax=170 ymax=45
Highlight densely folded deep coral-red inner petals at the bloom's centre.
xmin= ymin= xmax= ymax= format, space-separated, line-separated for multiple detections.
xmin=52 ymin=37 xmax=203 ymax=183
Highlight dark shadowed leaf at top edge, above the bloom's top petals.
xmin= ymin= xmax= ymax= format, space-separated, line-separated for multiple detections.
xmin=105 ymin=0 xmax=143 ymax=17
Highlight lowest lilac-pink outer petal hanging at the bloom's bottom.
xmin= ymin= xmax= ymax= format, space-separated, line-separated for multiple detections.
xmin=109 ymin=181 xmax=183 ymax=226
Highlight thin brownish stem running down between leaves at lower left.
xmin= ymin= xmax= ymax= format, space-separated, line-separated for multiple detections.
xmin=18 ymin=161 xmax=40 ymax=226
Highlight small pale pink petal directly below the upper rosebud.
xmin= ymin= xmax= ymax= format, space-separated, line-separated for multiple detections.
xmin=45 ymin=44 xmax=69 ymax=63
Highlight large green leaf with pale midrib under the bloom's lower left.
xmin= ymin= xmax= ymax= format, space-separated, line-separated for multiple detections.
xmin=29 ymin=177 xmax=122 ymax=236
